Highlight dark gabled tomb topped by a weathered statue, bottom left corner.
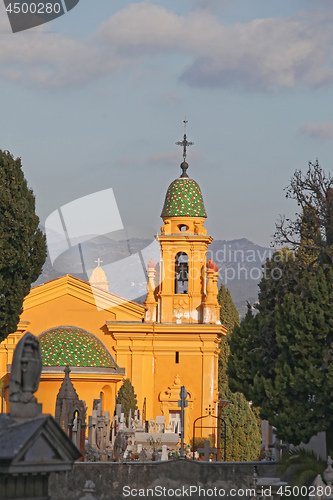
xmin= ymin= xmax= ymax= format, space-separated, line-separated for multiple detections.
xmin=0 ymin=332 xmax=80 ymax=500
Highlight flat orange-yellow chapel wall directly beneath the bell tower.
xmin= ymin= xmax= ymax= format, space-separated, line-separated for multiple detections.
xmin=107 ymin=323 xmax=226 ymax=442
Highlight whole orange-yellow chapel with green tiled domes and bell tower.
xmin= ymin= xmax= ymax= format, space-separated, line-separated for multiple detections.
xmin=0 ymin=133 xmax=227 ymax=442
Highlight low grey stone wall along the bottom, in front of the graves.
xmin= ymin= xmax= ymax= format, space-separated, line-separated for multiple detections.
xmin=50 ymin=460 xmax=280 ymax=500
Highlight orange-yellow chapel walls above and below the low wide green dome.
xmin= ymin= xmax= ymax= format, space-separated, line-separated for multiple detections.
xmin=0 ymin=278 xmax=144 ymax=415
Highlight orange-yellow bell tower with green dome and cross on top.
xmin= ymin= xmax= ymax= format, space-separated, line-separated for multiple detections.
xmin=156 ymin=120 xmax=219 ymax=324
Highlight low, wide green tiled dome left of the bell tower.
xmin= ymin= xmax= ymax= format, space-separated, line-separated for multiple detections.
xmin=38 ymin=326 xmax=116 ymax=367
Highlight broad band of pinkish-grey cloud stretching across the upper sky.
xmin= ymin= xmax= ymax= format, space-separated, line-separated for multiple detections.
xmin=0 ymin=1 xmax=333 ymax=90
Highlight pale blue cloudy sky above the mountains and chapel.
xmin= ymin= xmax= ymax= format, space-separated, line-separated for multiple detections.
xmin=0 ymin=0 xmax=333 ymax=246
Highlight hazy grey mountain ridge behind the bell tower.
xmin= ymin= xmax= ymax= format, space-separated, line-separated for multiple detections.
xmin=33 ymin=235 xmax=273 ymax=317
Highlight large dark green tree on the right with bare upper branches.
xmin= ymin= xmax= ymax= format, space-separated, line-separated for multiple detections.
xmin=229 ymin=163 xmax=333 ymax=450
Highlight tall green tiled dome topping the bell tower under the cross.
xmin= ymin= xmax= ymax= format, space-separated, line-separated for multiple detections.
xmin=161 ymin=177 xmax=207 ymax=217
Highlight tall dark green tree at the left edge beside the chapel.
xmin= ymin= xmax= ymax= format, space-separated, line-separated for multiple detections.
xmin=0 ymin=150 xmax=46 ymax=341
